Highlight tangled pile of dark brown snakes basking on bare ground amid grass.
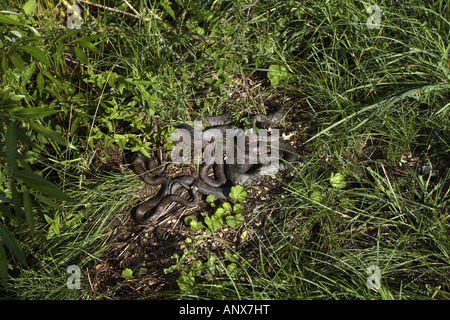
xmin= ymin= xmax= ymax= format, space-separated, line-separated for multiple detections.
xmin=132 ymin=102 xmax=298 ymax=225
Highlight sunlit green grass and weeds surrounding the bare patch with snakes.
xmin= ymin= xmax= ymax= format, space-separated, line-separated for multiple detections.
xmin=0 ymin=0 xmax=450 ymax=299
